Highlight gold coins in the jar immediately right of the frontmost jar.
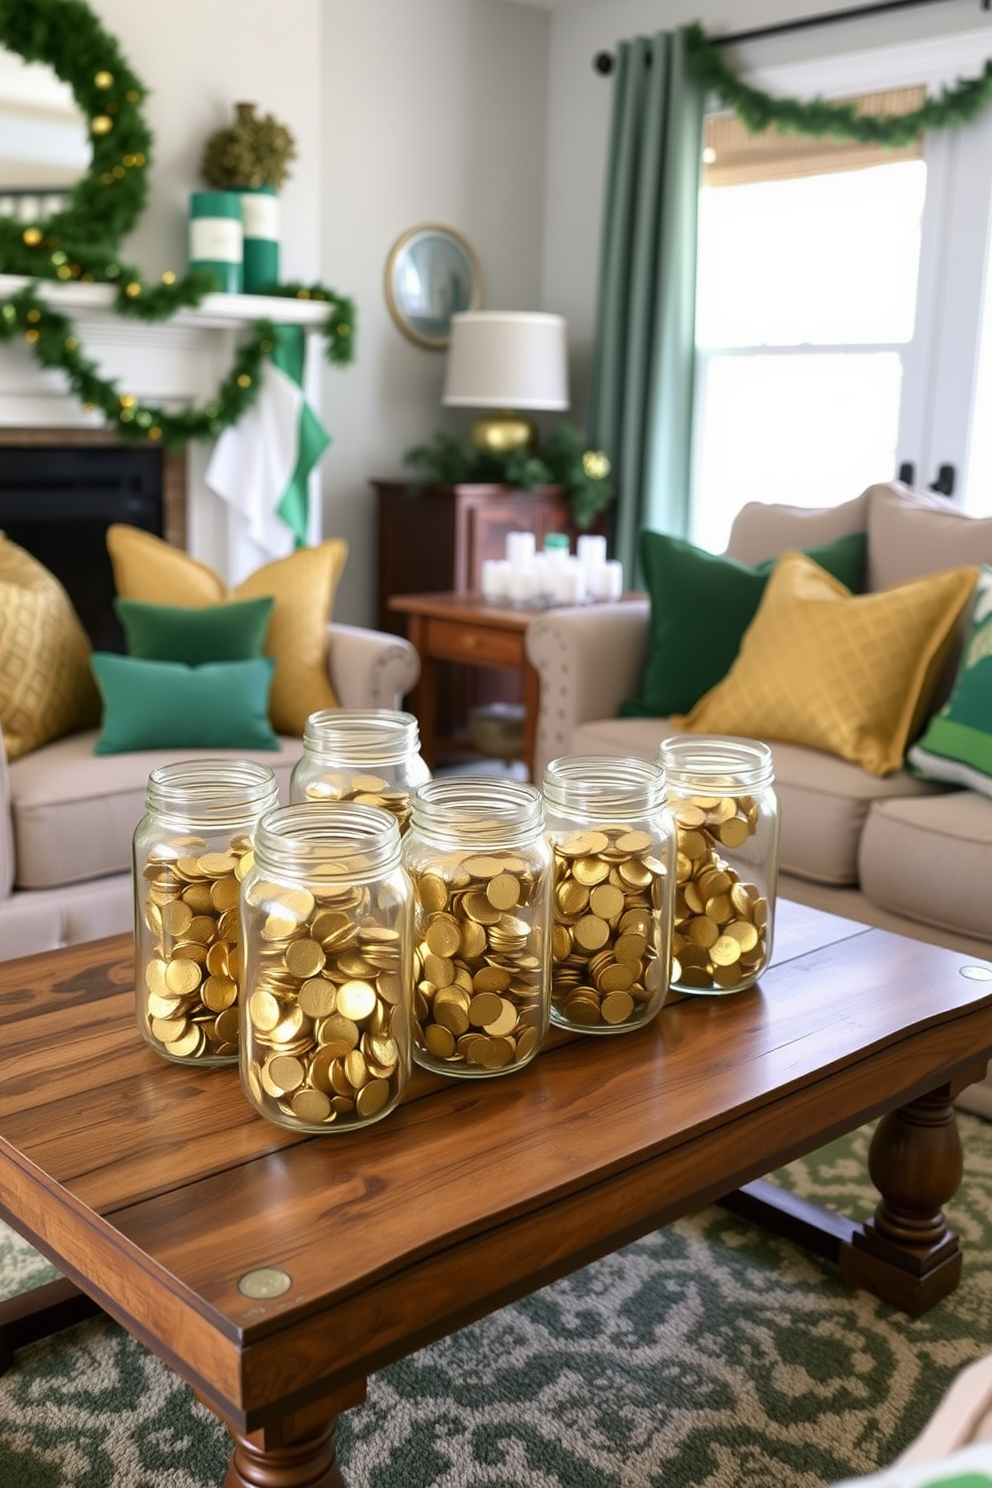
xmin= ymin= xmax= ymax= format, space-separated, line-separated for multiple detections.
xmin=410 ymin=853 xmax=547 ymax=1073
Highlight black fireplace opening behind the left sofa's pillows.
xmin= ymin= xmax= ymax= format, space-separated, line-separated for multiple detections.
xmin=0 ymin=445 xmax=164 ymax=652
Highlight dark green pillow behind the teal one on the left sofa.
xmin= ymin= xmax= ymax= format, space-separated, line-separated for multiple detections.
xmin=113 ymin=595 xmax=275 ymax=667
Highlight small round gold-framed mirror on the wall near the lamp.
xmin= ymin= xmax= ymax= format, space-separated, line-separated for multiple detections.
xmin=385 ymin=222 xmax=482 ymax=350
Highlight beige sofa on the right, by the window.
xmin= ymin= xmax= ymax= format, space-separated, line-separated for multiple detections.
xmin=526 ymin=484 xmax=992 ymax=1116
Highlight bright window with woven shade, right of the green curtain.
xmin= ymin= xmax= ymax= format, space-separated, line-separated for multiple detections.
xmin=692 ymin=89 xmax=927 ymax=551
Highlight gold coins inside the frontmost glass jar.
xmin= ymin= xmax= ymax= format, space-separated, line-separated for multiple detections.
xmin=242 ymin=866 xmax=409 ymax=1126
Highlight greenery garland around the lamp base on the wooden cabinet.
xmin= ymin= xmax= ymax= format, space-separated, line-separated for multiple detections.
xmin=403 ymin=424 xmax=614 ymax=528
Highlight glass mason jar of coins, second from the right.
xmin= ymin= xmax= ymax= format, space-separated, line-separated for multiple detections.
xmin=544 ymin=754 xmax=675 ymax=1033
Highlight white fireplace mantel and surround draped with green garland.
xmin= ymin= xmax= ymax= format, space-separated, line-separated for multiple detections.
xmin=0 ymin=274 xmax=327 ymax=576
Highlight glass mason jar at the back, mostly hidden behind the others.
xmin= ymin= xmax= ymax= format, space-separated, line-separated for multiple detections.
xmin=290 ymin=708 xmax=430 ymax=832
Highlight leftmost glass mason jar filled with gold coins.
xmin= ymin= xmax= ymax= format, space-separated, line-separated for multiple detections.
xmin=132 ymin=759 xmax=278 ymax=1064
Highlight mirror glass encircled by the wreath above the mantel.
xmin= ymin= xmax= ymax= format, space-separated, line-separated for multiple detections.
xmin=0 ymin=49 xmax=92 ymax=222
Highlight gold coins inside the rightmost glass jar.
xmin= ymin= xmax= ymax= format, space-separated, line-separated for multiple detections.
xmin=672 ymin=796 xmax=767 ymax=991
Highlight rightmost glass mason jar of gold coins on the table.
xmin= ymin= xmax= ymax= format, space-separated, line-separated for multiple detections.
xmin=657 ymin=734 xmax=779 ymax=994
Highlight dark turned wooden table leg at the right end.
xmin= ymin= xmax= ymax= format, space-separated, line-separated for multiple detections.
xmin=839 ymin=1085 xmax=962 ymax=1317
